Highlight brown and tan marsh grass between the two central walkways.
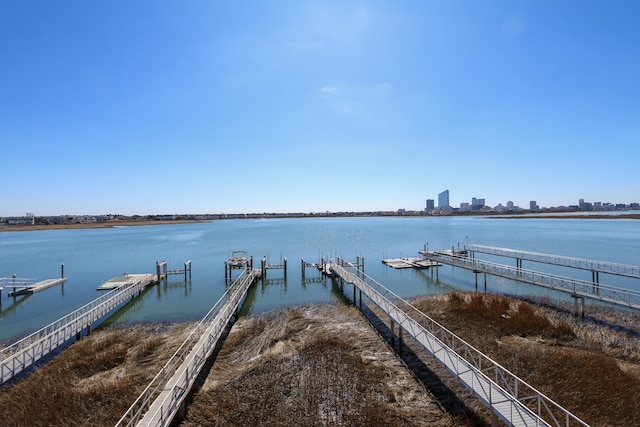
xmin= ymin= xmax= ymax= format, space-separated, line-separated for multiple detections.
xmin=184 ymin=306 xmax=458 ymax=426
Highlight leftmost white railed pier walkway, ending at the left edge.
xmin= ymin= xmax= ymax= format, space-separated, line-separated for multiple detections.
xmin=0 ymin=274 xmax=154 ymax=385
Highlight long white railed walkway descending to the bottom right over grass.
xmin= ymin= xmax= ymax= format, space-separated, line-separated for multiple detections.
xmin=330 ymin=258 xmax=588 ymax=427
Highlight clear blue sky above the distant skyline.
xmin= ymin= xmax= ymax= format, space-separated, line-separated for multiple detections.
xmin=0 ymin=0 xmax=640 ymax=216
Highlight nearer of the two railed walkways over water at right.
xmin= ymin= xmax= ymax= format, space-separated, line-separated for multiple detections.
xmin=423 ymin=252 xmax=640 ymax=309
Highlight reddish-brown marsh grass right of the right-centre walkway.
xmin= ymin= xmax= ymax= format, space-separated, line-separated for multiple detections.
xmin=414 ymin=293 xmax=640 ymax=426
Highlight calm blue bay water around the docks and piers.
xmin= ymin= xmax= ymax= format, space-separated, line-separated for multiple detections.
xmin=0 ymin=217 xmax=640 ymax=341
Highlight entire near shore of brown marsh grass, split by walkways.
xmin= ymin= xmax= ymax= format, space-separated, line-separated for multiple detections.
xmin=0 ymin=293 xmax=640 ymax=426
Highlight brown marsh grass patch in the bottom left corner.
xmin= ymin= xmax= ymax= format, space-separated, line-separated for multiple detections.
xmin=0 ymin=324 xmax=189 ymax=426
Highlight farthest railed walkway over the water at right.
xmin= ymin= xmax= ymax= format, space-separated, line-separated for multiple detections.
xmin=465 ymin=245 xmax=640 ymax=279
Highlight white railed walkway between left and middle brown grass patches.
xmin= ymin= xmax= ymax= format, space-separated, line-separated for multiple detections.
xmin=116 ymin=265 xmax=260 ymax=426
